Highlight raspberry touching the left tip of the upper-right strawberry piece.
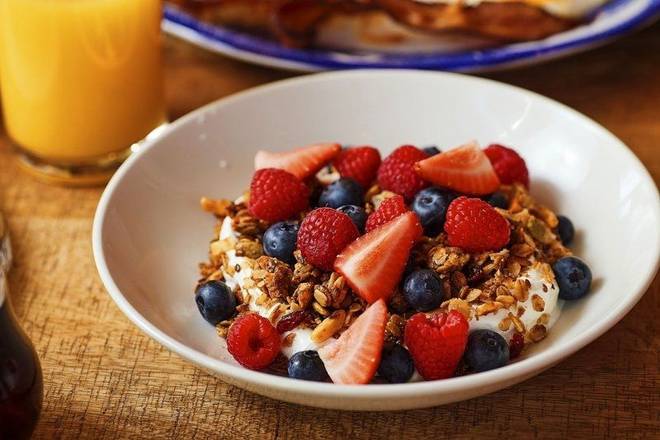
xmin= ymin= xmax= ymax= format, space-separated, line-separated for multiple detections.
xmin=378 ymin=145 xmax=428 ymax=200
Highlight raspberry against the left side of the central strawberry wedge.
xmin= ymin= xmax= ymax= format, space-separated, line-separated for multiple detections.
xmin=297 ymin=208 xmax=360 ymax=270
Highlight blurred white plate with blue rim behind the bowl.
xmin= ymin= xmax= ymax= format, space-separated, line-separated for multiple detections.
xmin=163 ymin=0 xmax=660 ymax=72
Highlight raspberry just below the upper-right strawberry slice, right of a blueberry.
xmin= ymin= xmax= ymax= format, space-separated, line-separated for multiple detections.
xmin=445 ymin=196 xmax=510 ymax=252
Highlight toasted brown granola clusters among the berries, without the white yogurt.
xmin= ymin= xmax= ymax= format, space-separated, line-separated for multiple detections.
xmin=199 ymin=184 xmax=571 ymax=354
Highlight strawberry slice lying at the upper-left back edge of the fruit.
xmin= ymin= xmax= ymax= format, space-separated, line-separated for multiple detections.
xmin=254 ymin=143 xmax=341 ymax=180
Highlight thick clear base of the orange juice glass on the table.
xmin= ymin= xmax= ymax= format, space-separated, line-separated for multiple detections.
xmin=13 ymin=123 xmax=167 ymax=186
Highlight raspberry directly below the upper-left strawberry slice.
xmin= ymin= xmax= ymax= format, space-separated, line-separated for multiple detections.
xmin=249 ymin=168 xmax=309 ymax=222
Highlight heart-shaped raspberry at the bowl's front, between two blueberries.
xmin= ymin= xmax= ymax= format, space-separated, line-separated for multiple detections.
xmin=404 ymin=310 xmax=470 ymax=380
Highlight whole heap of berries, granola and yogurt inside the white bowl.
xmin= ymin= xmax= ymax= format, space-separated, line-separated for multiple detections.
xmin=195 ymin=143 xmax=592 ymax=384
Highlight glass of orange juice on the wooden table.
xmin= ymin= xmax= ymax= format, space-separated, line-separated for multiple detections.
xmin=0 ymin=0 xmax=166 ymax=185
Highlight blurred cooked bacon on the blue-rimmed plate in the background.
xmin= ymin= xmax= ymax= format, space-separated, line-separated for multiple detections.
xmin=170 ymin=0 xmax=577 ymax=46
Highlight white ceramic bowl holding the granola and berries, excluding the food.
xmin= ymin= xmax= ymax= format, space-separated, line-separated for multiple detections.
xmin=93 ymin=71 xmax=660 ymax=410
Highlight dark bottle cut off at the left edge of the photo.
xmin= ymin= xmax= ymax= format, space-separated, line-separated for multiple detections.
xmin=0 ymin=213 xmax=43 ymax=440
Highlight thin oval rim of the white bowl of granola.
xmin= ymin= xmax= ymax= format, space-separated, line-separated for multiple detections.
xmin=92 ymin=69 xmax=660 ymax=399
